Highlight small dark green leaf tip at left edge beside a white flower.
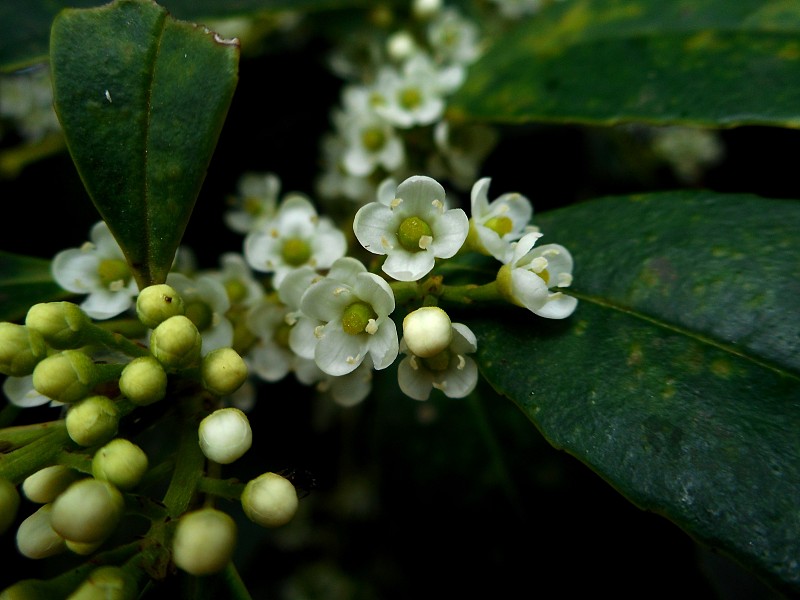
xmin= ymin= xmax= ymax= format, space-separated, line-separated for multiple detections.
xmin=0 ymin=252 xmax=69 ymax=321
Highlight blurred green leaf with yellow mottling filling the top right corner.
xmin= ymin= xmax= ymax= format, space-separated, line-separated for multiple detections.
xmin=452 ymin=0 xmax=800 ymax=127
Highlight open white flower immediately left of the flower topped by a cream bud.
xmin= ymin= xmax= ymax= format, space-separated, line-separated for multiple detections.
xmin=300 ymin=257 xmax=398 ymax=376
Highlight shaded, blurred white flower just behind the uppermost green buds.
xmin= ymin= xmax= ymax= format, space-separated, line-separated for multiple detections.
xmin=167 ymin=273 xmax=233 ymax=355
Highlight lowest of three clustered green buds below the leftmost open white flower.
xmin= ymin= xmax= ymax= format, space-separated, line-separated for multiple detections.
xmin=33 ymin=350 xmax=97 ymax=403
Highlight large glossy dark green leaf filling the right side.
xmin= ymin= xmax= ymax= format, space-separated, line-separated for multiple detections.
xmin=468 ymin=192 xmax=800 ymax=592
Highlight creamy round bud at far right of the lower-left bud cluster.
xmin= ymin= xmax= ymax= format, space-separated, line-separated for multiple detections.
xmin=242 ymin=473 xmax=298 ymax=527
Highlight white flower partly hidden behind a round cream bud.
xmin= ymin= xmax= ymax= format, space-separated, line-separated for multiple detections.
xmin=397 ymin=323 xmax=478 ymax=400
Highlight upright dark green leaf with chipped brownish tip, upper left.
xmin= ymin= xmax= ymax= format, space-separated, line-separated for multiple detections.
xmin=51 ymin=0 xmax=239 ymax=288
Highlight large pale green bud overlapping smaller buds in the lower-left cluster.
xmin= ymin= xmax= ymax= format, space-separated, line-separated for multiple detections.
xmin=50 ymin=478 xmax=125 ymax=544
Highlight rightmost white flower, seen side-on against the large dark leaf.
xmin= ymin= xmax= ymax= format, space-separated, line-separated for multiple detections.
xmin=497 ymin=232 xmax=578 ymax=319
